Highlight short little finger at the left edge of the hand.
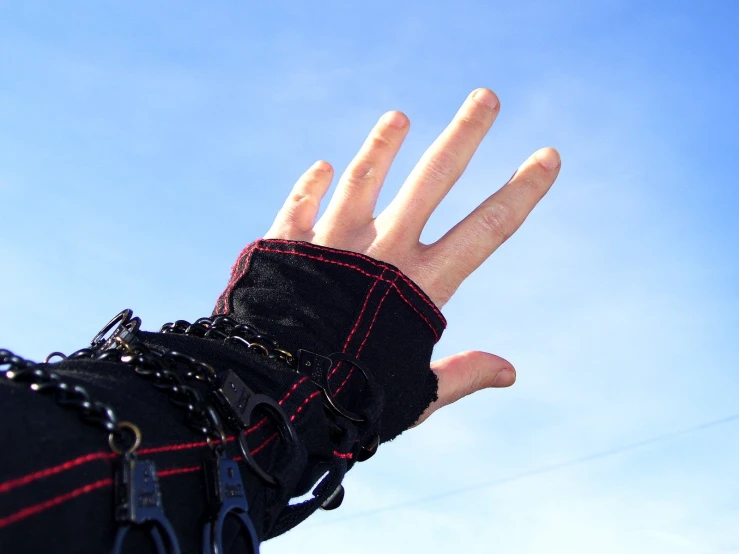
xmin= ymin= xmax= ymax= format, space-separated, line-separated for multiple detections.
xmin=264 ymin=161 xmax=334 ymax=239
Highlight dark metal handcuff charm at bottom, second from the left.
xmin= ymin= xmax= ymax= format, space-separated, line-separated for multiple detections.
xmin=203 ymin=453 xmax=259 ymax=554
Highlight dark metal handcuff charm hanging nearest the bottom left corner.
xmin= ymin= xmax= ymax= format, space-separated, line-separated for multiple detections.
xmin=113 ymin=452 xmax=180 ymax=554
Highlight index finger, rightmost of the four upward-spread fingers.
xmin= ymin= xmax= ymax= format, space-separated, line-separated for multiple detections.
xmin=424 ymin=148 xmax=561 ymax=304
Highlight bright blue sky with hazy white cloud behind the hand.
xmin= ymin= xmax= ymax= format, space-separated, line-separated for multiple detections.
xmin=0 ymin=0 xmax=739 ymax=554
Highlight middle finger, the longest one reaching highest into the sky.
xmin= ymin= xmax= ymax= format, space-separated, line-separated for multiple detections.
xmin=378 ymin=88 xmax=500 ymax=241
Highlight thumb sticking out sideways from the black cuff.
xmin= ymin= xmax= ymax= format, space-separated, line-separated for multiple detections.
xmin=416 ymin=352 xmax=516 ymax=425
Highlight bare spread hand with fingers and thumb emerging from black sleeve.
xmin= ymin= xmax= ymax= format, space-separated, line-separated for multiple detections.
xmin=265 ymin=89 xmax=560 ymax=423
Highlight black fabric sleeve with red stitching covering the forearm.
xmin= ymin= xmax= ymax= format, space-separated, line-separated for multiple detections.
xmin=0 ymin=240 xmax=445 ymax=552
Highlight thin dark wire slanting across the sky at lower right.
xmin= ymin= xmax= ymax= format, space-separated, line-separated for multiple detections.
xmin=305 ymin=413 xmax=739 ymax=529
